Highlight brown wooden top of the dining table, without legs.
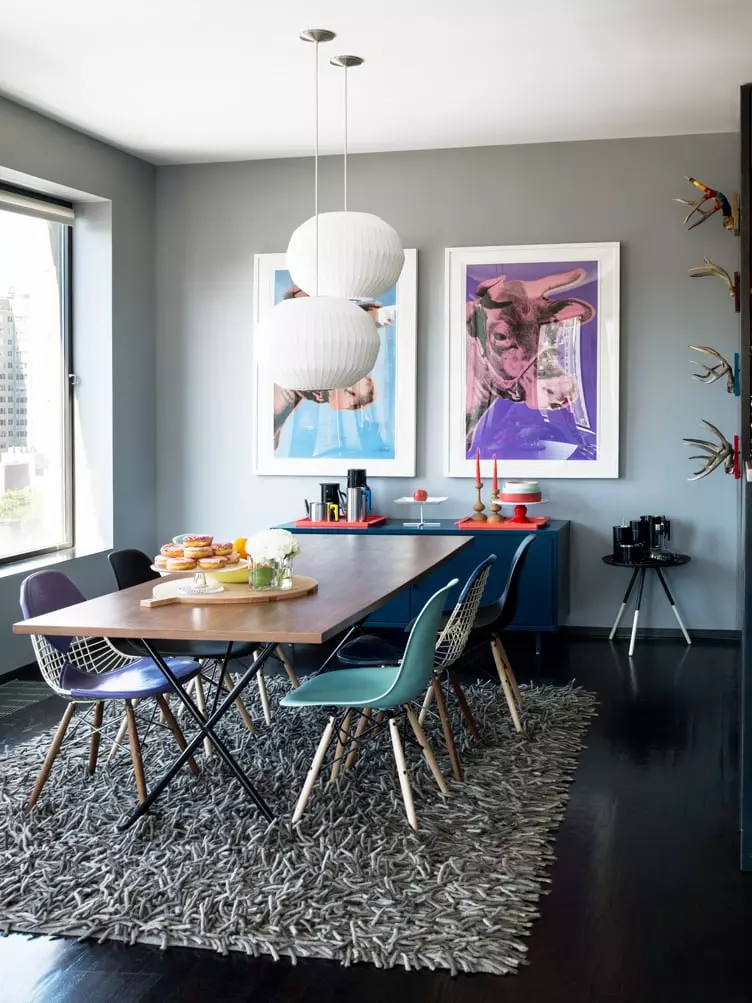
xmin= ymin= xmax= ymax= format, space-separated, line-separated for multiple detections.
xmin=13 ymin=535 xmax=472 ymax=644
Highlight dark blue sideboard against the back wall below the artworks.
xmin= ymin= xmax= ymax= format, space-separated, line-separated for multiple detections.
xmin=281 ymin=519 xmax=570 ymax=634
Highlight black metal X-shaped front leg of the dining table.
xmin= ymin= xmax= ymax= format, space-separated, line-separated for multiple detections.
xmin=119 ymin=640 xmax=276 ymax=829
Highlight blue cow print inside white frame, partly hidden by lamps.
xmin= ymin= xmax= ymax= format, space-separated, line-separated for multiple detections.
xmin=274 ymin=269 xmax=398 ymax=460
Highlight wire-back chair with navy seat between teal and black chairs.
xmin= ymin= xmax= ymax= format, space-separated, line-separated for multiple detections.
xmin=338 ymin=554 xmax=496 ymax=780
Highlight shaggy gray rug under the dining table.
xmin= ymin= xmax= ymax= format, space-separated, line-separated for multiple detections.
xmin=0 ymin=679 xmax=596 ymax=974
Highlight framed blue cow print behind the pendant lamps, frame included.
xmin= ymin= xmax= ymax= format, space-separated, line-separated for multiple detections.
xmin=254 ymin=250 xmax=417 ymax=477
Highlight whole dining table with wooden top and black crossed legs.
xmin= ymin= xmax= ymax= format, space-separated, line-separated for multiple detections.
xmin=13 ymin=532 xmax=471 ymax=828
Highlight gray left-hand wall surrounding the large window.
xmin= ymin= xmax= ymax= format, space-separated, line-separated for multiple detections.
xmin=0 ymin=98 xmax=156 ymax=672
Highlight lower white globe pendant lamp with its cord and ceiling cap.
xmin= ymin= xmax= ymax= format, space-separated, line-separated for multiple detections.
xmin=257 ymin=28 xmax=380 ymax=391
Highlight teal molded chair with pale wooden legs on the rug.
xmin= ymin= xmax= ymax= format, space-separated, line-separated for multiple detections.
xmin=281 ymin=578 xmax=457 ymax=831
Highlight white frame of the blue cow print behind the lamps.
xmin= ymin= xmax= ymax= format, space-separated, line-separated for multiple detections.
xmin=254 ymin=249 xmax=417 ymax=479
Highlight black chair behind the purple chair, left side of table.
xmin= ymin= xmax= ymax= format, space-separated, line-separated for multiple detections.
xmin=107 ymin=549 xmax=300 ymax=730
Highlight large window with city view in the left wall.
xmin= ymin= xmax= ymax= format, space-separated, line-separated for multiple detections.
xmin=0 ymin=187 xmax=73 ymax=564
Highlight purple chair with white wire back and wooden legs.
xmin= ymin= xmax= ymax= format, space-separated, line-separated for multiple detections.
xmin=20 ymin=571 xmax=200 ymax=811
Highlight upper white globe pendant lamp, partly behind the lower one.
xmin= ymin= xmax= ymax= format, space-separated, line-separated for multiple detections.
xmin=287 ymin=56 xmax=405 ymax=300
